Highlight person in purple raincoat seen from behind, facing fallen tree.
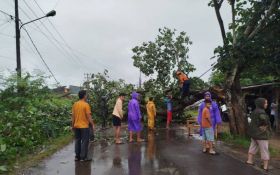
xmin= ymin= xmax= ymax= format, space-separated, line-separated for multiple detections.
xmin=128 ymin=92 xmax=143 ymax=142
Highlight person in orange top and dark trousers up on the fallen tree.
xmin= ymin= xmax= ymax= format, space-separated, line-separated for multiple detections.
xmin=176 ymin=70 xmax=190 ymax=99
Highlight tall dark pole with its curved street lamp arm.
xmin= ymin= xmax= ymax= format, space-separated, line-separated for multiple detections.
xmin=15 ymin=6 xmax=56 ymax=78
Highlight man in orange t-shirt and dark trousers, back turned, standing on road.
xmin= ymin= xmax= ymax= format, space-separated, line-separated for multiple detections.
xmin=72 ymin=90 xmax=94 ymax=161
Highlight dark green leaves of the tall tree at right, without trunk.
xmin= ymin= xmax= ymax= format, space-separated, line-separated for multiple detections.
xmin=210 ymin=0 xmax=280 ymax=79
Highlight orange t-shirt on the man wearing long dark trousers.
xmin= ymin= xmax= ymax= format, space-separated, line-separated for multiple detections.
xmin=72 ymin=100 xmax=91 ymax=128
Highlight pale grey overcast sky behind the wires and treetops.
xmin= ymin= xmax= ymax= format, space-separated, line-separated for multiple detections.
xmin=0 ymin=0 xmax=230 ymax=85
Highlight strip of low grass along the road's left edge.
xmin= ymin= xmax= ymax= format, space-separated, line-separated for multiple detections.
xmin=10 ymin=132 xmax=73 ymax=174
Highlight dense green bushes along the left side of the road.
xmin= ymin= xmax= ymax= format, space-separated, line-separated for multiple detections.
xmin=0 ymin=74 xmax=72 ymax=172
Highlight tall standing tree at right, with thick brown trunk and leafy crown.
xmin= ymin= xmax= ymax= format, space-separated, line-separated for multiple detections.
xmin=209 ymin=0 xmax=280 ymax=135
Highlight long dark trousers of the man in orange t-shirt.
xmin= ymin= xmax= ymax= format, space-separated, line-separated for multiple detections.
xmin=75 ymin=128 xmax=89 ymax=159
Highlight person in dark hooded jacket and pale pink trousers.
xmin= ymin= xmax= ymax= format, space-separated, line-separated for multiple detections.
xmin=246 ymin=98 xmax=271 ymax=171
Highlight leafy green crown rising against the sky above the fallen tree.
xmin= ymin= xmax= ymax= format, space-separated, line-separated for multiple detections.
xmin=132 ymin=28 xmax=195 ymax=89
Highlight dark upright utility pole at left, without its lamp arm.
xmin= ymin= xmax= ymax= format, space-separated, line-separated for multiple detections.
xmin=15 ymin=0 xmax=21 ymax=78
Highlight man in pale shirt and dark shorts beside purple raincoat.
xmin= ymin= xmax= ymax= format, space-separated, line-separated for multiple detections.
xmin=113 ymin=93 xmax=125 ymax=144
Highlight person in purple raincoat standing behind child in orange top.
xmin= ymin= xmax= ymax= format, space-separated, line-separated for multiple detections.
xmin=197 ymin=92 xmax=222 ymax=135
